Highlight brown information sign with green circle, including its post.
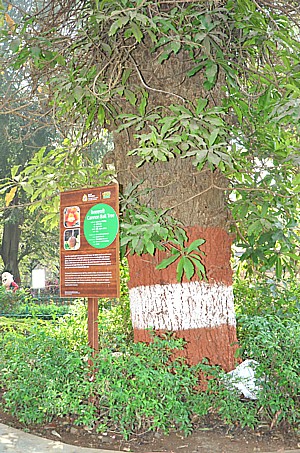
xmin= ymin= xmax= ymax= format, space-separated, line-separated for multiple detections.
xmin=60 ymin=184 xmax=120 ymax=351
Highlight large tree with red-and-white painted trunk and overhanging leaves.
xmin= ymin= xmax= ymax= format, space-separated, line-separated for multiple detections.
xmin=1 ymin=0 xmax=299 ymax=369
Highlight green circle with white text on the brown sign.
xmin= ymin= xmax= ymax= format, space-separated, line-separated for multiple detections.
xmin=83 ymin=203 xmax=119 ymax=249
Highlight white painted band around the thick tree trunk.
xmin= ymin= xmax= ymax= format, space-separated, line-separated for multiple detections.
xmin=129 ymin=282 xmax=236 ymax=331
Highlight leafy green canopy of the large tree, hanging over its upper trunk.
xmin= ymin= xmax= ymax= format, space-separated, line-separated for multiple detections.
xmin=1 ymin=0 xmax=300 ymax=277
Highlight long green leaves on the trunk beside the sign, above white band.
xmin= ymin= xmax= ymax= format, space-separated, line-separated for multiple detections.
xmin=120 ymin=183 xmax=206 ymax=282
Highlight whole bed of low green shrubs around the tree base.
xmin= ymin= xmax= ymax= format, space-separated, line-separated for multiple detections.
xmin=0 ymin=276 xmax=300 ymax=437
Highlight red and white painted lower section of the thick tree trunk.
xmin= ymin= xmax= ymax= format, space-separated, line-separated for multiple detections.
xmin=129 ymin=227 xmax=237 ymax=370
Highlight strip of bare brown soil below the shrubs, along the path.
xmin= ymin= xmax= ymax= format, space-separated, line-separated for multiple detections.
xmin=0 ymin=410 xmax=300 ymax=453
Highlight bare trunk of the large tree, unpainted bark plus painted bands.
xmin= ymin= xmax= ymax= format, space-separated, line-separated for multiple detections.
xmin=112 ymin=40 xmax=237 ymax=370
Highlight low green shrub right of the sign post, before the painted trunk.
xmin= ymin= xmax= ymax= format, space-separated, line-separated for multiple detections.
xmin=90 ymin=337 xmax=210 ymax=437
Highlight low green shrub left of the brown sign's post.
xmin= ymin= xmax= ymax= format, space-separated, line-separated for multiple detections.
xmin=0 ymin=324 xmax=91 ymax=423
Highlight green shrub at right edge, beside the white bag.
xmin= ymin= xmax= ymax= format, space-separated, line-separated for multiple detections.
xmin=239 ymin=308 xmax=300 ymax=426
